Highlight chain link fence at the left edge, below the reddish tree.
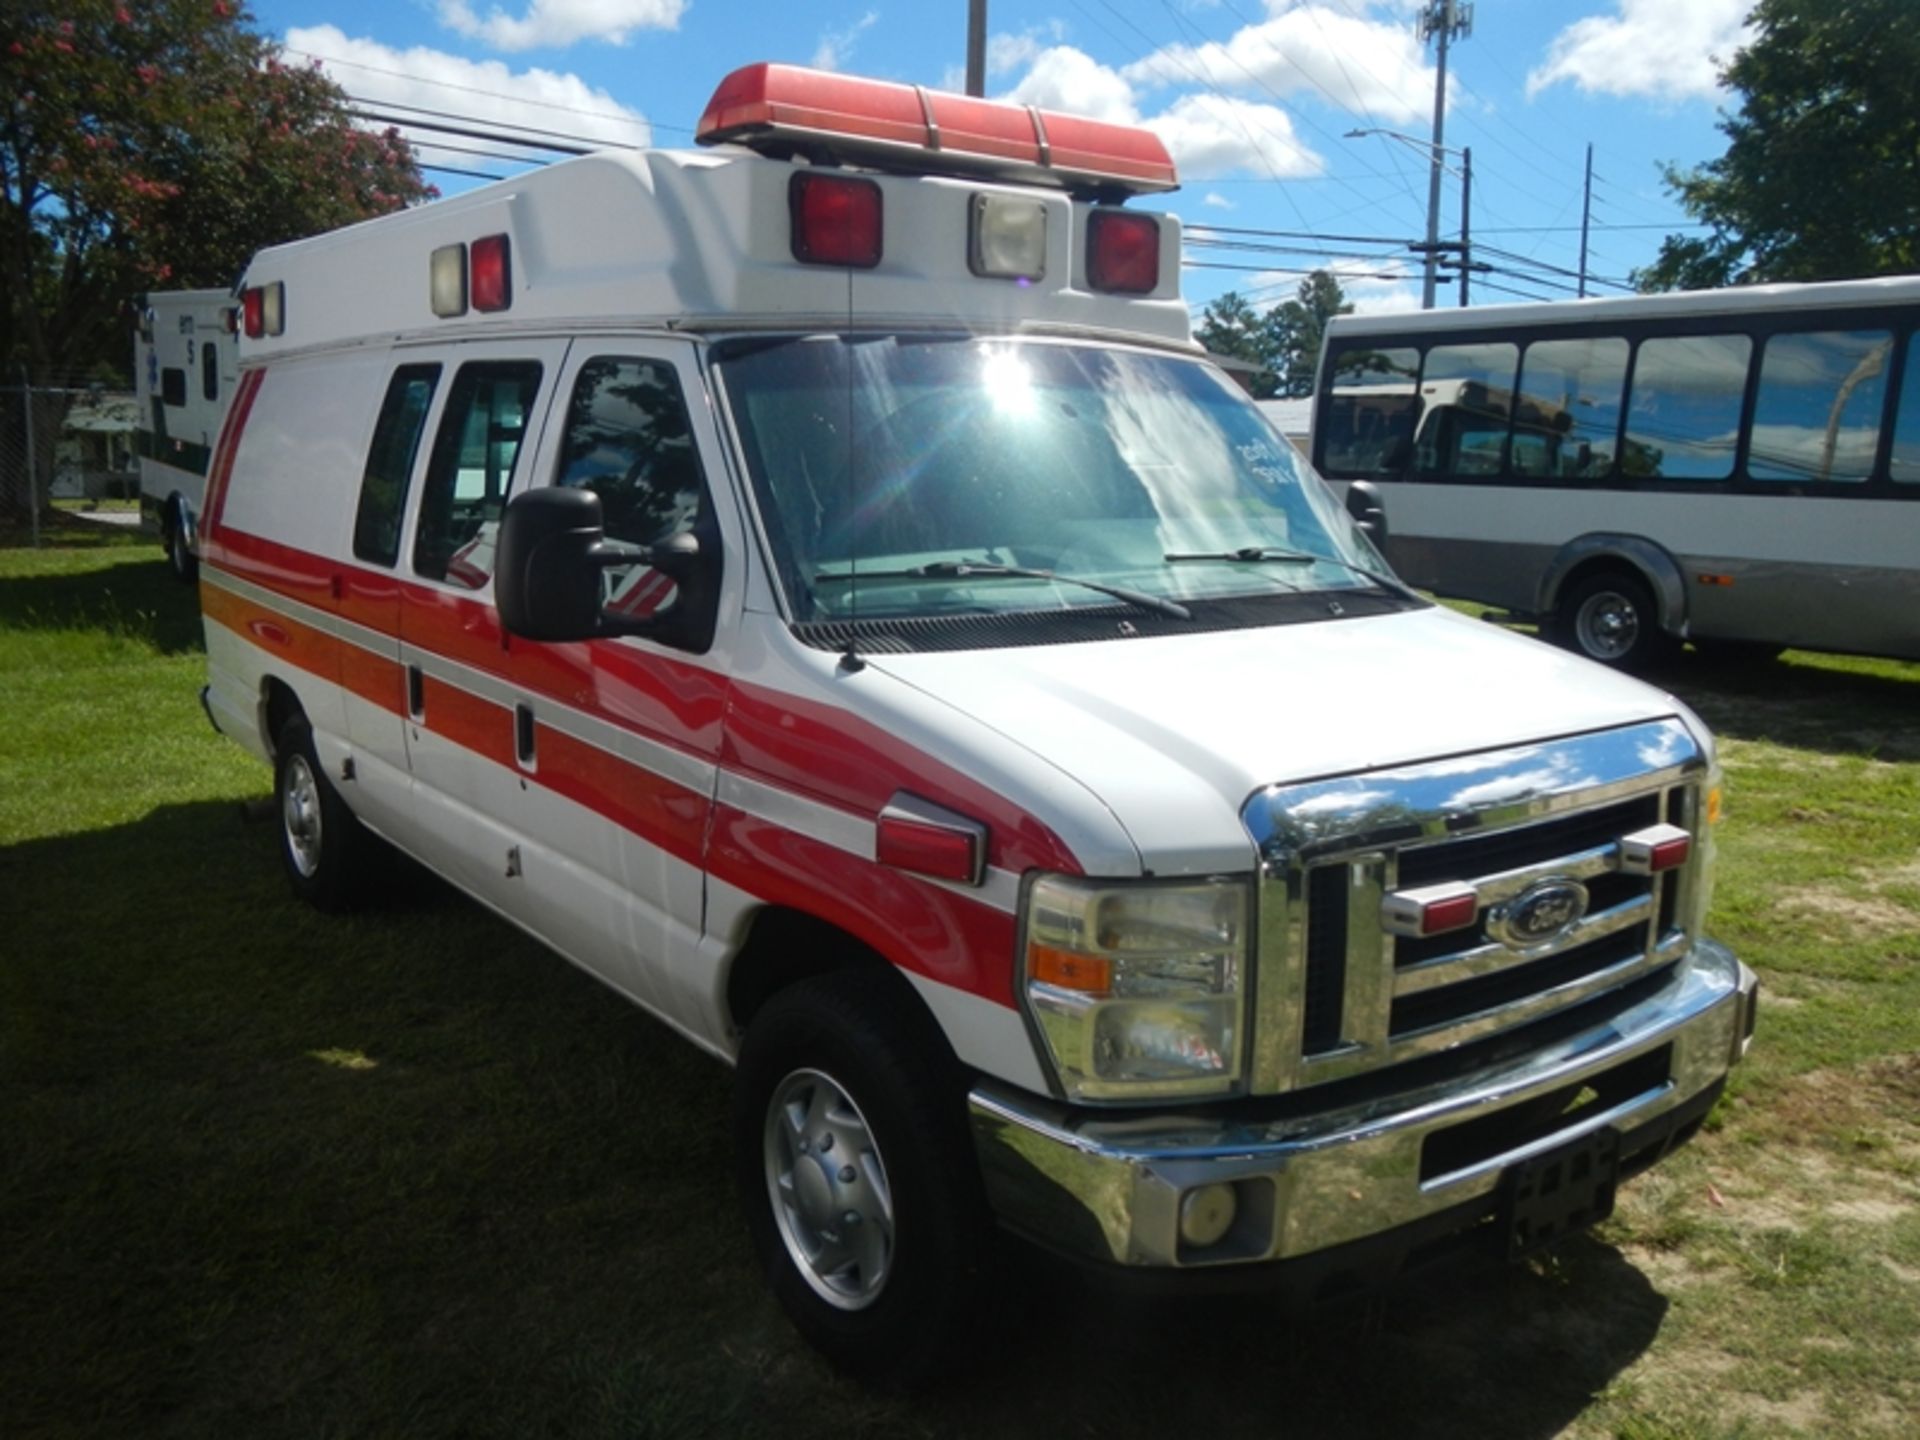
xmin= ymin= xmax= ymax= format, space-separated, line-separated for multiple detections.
xmin=0 ymin=384 xmax=140 ymax=545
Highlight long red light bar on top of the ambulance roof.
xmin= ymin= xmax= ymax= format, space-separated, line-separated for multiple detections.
xmin=693 ymin=63 xmax=1179 ymax=196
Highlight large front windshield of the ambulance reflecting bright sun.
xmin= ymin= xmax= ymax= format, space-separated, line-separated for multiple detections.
xmin=716 ymin=336 xmax=1384 ymax=620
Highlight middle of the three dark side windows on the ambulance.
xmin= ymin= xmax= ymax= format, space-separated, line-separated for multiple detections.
xmin=413 ymin=361 xmax=540 ymax=589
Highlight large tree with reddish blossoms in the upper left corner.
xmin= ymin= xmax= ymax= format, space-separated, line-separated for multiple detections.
xmin=0 ymin=0 xmax=432 ymax=513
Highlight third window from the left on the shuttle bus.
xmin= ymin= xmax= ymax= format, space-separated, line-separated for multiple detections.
xmin=1509 ymin=338 xmax=1628 ymax=480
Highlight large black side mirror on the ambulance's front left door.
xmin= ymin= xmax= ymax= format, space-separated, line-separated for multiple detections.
xmin=493 ymin=486 xmax=720 ymax=649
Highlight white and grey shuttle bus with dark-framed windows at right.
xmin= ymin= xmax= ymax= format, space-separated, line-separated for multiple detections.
xmin=1313 ymin=276 xmax=1920 ymax=668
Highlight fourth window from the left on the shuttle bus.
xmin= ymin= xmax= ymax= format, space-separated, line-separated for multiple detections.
xmin=1620 ymin=334 xmax=1753 ymax=480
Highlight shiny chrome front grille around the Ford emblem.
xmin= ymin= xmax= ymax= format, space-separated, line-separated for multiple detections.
xmin=1246 ymin=720 xmax=1705 ymax=1092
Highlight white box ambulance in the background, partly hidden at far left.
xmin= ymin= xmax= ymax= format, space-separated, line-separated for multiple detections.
xmin=132 ymin=290 xmax=240 ymax=580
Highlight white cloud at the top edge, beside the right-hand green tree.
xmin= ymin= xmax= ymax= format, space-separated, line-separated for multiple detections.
xmin=1526 ymin=0 xmax=1753 ymax=100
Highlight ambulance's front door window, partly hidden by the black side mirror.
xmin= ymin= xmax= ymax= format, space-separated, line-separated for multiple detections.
xmin=559 ymin=355 xmax=707 ymax=616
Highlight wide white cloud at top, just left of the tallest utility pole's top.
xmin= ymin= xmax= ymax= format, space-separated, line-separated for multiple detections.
xmin=1121 ymin=0 xmax=1434 ymax=123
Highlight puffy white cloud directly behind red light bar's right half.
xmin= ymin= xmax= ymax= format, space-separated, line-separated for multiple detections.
xmin=1000 ymin=44 xmax=1323 ymax=180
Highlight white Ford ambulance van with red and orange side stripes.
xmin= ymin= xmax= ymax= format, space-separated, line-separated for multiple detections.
xmin=202 ymin=65 xmax=1757 ymax=1379
